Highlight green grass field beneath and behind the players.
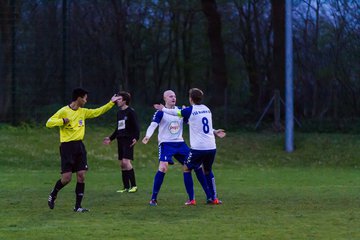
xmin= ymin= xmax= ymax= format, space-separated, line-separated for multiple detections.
xmin=0 ymin=123 xmax=360 ymax=239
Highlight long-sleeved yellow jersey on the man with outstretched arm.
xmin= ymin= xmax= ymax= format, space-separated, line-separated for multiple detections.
xmin=46 ymin=101 xmax=115 ymax=142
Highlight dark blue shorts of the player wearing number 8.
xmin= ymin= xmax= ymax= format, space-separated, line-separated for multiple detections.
xmin=185 ymin=149 xmax=216 ymax=172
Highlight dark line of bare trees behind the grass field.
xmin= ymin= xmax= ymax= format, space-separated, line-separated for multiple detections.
xmin=0 ymin=0 xmax=360 ymax=129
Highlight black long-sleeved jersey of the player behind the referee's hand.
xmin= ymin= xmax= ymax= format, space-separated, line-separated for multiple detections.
xmin=110 ymin=107 xmax=140 ymax=141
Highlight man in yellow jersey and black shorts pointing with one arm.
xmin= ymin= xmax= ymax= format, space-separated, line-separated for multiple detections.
xmin=46 ymin=88 xmax=120 ymax=212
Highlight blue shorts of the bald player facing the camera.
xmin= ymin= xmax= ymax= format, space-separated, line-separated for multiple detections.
xmin=159 ymin=142 xmax=190 ymax=165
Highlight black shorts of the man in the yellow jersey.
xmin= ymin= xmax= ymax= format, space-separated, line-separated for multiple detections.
xmin=60 ymin=141 xmax=88 ymax=173
